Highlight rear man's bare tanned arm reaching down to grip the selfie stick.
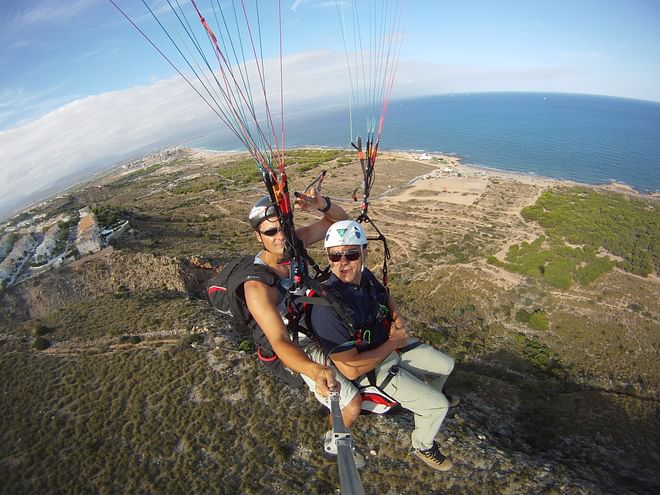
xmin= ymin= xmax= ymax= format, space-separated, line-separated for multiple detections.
xmin=243 ymin=280 xmax=339 ymax=395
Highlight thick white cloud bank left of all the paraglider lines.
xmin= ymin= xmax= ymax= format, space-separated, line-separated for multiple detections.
xmin=0 ymin=79 xmax=210 ymax=211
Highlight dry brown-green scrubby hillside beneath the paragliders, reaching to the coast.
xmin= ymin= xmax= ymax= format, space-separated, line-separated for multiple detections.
xmin=0 ymin=150 xmax=660 ymax=495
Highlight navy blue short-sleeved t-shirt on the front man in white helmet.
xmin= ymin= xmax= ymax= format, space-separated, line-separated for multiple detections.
xmin=311 ymin=268 xmax=389 ymax=354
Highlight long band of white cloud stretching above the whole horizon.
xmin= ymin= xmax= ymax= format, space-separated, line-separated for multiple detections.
xmin=0 ymin=51 xmax=644 ymax=217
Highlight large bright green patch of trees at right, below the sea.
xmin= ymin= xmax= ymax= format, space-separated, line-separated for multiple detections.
xmin=487 ymin=188 xmax=660 ymax=289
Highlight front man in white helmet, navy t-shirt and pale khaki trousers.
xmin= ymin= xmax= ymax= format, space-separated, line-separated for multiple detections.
xmin=310 ymin=220 xmax=458 ymax=471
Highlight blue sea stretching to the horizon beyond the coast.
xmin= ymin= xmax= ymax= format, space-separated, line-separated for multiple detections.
xmin=186 ymin=93 xmax=660 ymax=193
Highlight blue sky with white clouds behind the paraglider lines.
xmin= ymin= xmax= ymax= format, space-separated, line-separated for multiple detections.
xmin=0 ymin=0 xmax=660 ymax=218
